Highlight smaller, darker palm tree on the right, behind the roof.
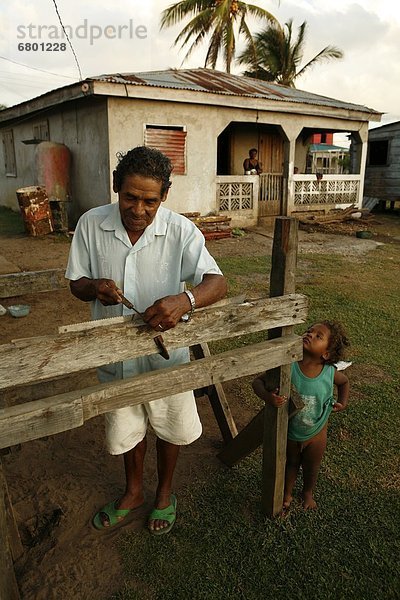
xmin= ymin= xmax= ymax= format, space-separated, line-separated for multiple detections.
xmin=238 ymin=19 xmax=343 ymax=88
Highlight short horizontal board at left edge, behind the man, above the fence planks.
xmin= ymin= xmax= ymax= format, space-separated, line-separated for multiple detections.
xmin=0 ymin=269 xmax=68 ymax=298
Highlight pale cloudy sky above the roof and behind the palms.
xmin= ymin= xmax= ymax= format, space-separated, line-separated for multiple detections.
xmin=0 ymin=0 xmax=400 ymax=132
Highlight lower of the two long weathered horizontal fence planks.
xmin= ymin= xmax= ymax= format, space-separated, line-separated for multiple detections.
xmin=0 ymin=336 xmax=302 ymax=448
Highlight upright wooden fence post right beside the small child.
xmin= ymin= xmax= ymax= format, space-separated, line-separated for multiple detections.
xmin=261 ymin=217 xmax=298 ymax=517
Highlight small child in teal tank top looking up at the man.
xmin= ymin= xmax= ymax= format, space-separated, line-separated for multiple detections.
xmin=253 ymin=321 xmax=349 ymax=509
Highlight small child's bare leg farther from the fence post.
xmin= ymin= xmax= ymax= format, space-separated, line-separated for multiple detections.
xmin=301 ymin=426 xmax=327 ymax=509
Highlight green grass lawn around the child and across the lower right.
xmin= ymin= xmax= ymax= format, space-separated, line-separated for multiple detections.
xmin=114 ymin=226 xmax=400 ymax=600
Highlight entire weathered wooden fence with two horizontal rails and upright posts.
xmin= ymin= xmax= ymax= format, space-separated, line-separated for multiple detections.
xmin=0 ymin=217 xmax=307 ymax=600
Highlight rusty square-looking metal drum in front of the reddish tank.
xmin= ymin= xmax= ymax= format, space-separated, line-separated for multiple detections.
xmin=16 ymin=185 xmax=54 ymax=236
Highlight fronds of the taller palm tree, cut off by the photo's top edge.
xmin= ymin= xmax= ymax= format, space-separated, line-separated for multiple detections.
xmin=161 ymin=0 xmax=276 ymax=73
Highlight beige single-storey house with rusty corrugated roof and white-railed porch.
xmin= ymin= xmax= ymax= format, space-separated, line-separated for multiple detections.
xmin=0 ymin=69 xmax=381 ymax=226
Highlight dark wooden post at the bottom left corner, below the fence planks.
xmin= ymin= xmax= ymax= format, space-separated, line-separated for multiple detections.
xmin=0 ymin=464 xmax=20 ymax=600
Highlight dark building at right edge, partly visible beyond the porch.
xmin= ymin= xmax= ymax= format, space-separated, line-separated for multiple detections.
xmin=364 ymin=121 xmax=400 ymax=208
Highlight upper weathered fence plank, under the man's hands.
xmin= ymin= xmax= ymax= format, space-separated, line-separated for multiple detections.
xmin=0 ymin=294 xmax=307 ymax=389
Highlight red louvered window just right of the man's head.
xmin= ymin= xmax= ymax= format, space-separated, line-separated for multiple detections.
xmin=144 ymin=125 xmax=186 ymax=175
